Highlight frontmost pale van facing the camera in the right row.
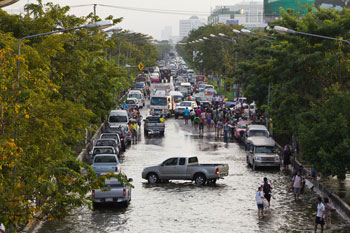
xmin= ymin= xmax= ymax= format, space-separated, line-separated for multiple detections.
xmin=247 ymin=137 xmax=281 ymax=170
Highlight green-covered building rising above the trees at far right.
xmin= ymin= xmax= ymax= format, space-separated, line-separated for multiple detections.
xmin=264 ymin=0 xmax=350 ymax=22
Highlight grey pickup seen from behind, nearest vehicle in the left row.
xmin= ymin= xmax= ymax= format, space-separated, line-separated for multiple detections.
xmin=92 ymin=174 xmax=133 ymax=208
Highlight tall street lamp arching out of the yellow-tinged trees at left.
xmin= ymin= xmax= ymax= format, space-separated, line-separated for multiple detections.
xmin=17 ymin=20 xmax=113 ymax=82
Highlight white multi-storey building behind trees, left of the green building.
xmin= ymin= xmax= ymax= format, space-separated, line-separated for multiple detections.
xmin=208 ymin=1 xmax=267 ymax=28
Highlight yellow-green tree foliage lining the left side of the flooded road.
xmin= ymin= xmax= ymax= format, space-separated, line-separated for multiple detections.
xmin=0 ymin=1 xmax=158 ymax=231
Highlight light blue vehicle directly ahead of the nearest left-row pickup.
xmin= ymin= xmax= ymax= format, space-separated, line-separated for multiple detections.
xmin=91 ymin=154 xmax=120 ymax=175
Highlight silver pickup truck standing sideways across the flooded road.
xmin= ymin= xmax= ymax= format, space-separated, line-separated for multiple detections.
xmin=142 ymin=157 xmax=229 ymax=185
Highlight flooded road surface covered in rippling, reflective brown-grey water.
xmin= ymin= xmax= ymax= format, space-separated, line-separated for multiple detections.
xmin=36 ymin=106 xmax=350 ymax=233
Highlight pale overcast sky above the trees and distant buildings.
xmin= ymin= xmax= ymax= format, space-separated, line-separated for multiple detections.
xmin=3 ymin=0 xmax=256 ymax=39
